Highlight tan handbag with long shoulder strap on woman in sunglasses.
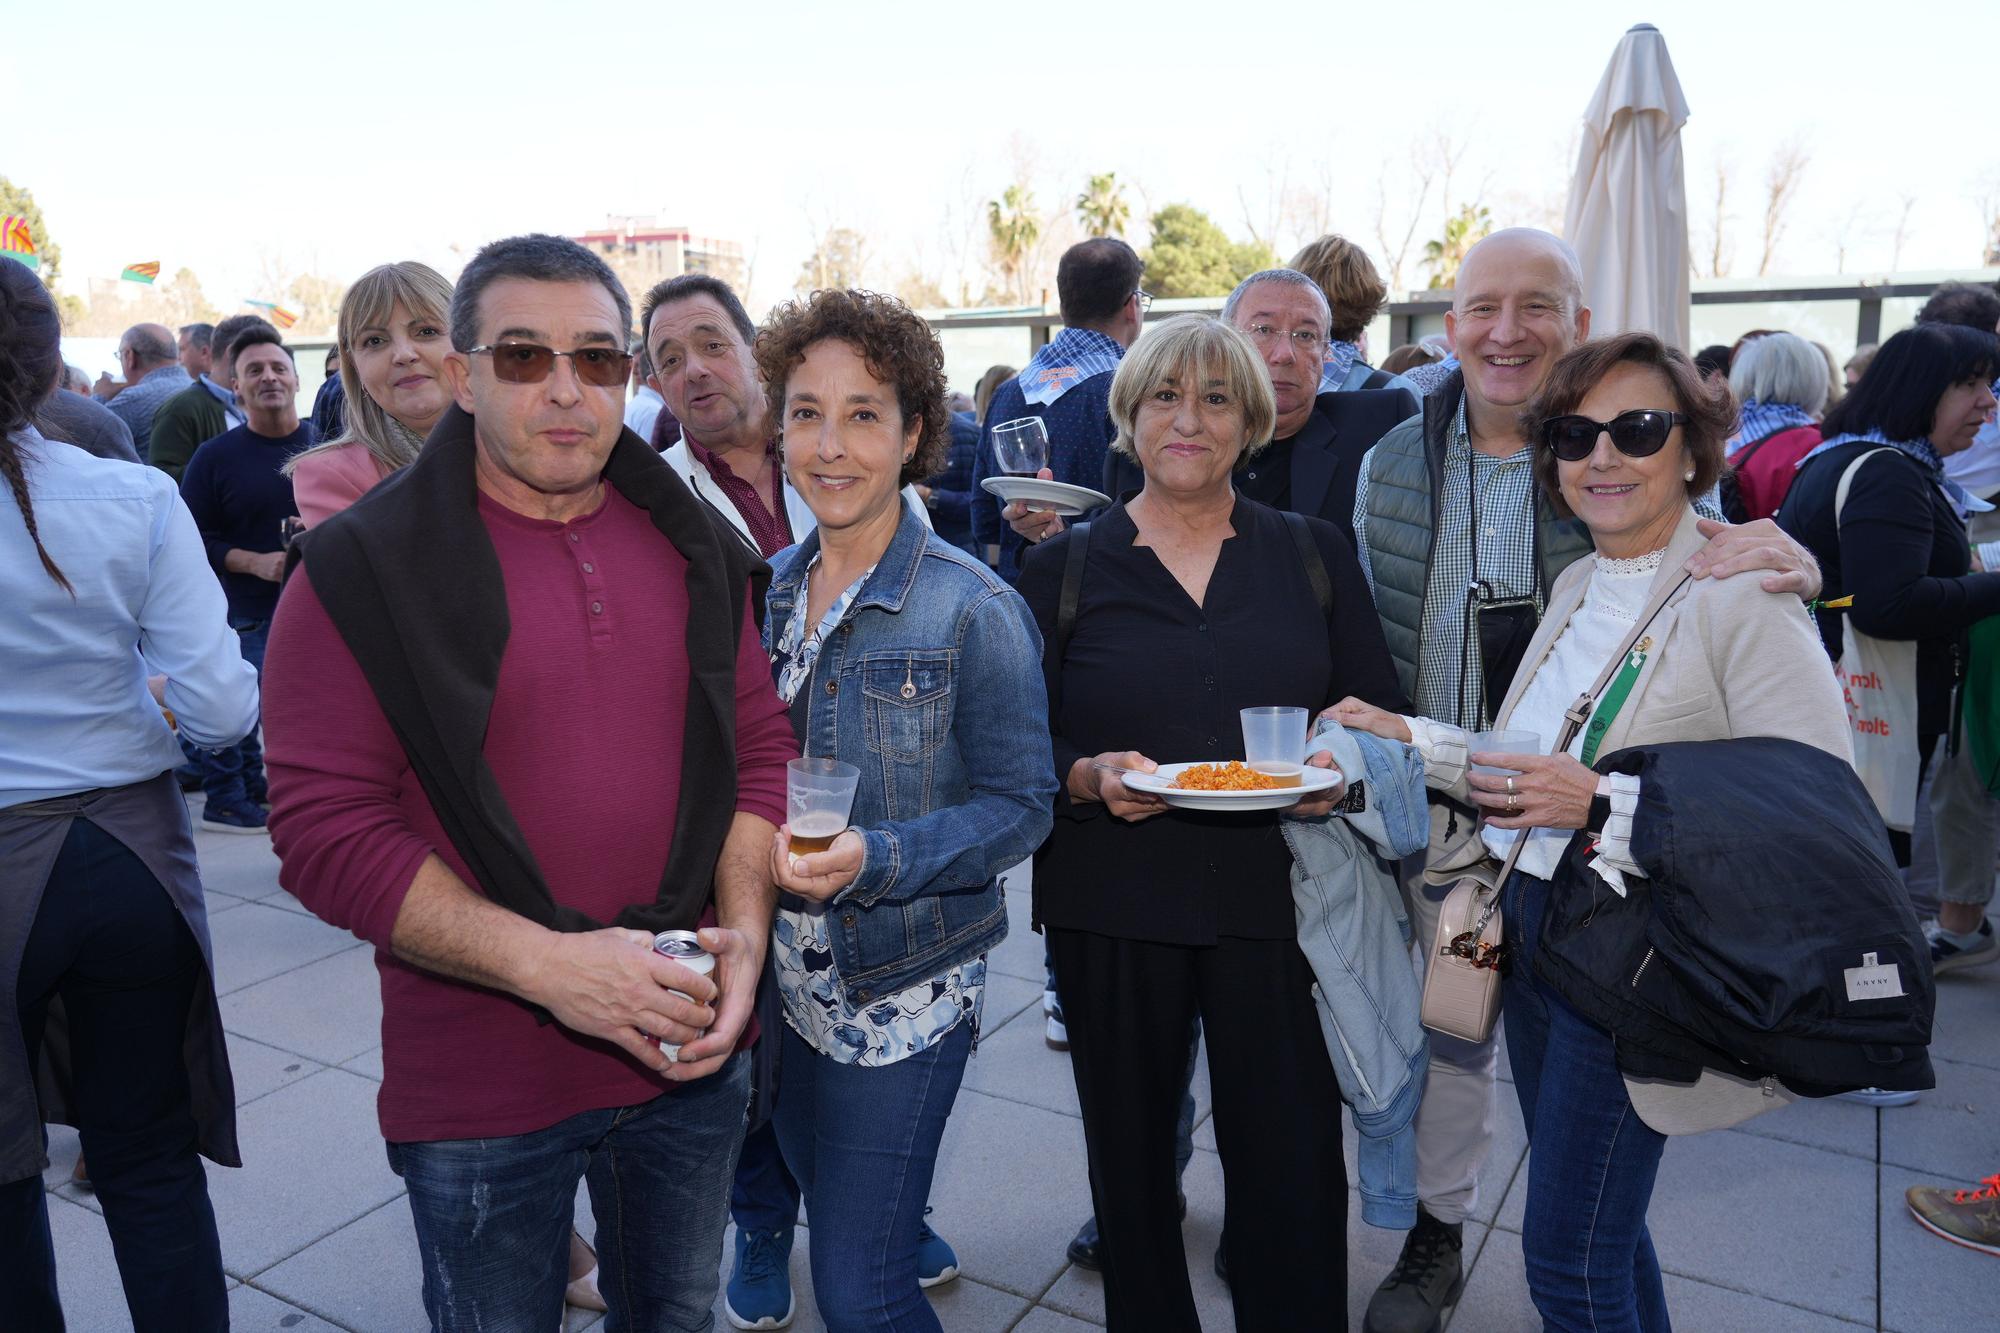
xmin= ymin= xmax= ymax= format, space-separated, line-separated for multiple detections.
xmin=1420 ymin=576 xmax=1686 ymax=1043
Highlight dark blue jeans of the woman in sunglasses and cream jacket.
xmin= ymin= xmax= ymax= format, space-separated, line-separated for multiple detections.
xmin=1502 ymin=873 xmax=1672 ymax=1333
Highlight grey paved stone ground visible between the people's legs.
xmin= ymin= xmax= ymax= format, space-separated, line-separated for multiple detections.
xmin=35 ymin=800 xmax=2000 ymax=1333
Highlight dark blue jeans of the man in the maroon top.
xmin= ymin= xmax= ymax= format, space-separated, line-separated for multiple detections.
xmin=388 ymin=1051 xmax=750 ymax=1333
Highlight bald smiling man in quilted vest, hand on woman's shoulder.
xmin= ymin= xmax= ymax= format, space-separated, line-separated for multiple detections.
xmin=1354 ymin=228 xmax=1820 ymax=1333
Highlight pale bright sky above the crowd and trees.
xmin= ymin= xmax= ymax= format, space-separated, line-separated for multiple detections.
xmin=0 ymin=0 xmax=2000 ymax=314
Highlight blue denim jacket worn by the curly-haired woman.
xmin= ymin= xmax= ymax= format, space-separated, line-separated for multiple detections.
xmin=764 ymin=510 xmax=1056 ymax=1005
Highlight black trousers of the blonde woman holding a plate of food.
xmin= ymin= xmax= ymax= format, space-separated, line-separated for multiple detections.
xmin=1048 ymin=929 xmax=1348 ymax=1333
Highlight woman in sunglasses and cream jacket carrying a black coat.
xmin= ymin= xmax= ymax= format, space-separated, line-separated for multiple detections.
xmin=1334 ymin=332 xmax=1848 ymax=1333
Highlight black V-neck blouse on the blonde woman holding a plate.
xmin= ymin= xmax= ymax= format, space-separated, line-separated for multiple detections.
xmin=1018 ymin=498 xmax=1406 ymax=945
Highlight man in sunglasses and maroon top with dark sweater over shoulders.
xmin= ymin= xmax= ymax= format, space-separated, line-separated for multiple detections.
xmin=264 ymin=236 xmax=798 ymax=1333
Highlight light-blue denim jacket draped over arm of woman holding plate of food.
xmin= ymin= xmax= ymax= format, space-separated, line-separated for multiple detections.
xmin=1280 ymin=727 xmax=1430 ymax=1231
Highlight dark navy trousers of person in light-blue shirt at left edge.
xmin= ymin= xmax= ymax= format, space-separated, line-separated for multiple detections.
xmin=0 ymin=819 xmax=228 ymax=1333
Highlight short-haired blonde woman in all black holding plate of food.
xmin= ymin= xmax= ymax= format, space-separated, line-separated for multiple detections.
xmin=1020 ymin=316 xmax=1400 ymax=1333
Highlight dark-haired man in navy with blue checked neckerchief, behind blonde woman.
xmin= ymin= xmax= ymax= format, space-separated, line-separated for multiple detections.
xmin=972 ymin=236 xmax=1152 ymax=582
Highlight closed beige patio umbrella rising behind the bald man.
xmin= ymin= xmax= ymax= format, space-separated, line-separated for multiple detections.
xmin=1562 ymin=24 xmax=1688 ymax=350
